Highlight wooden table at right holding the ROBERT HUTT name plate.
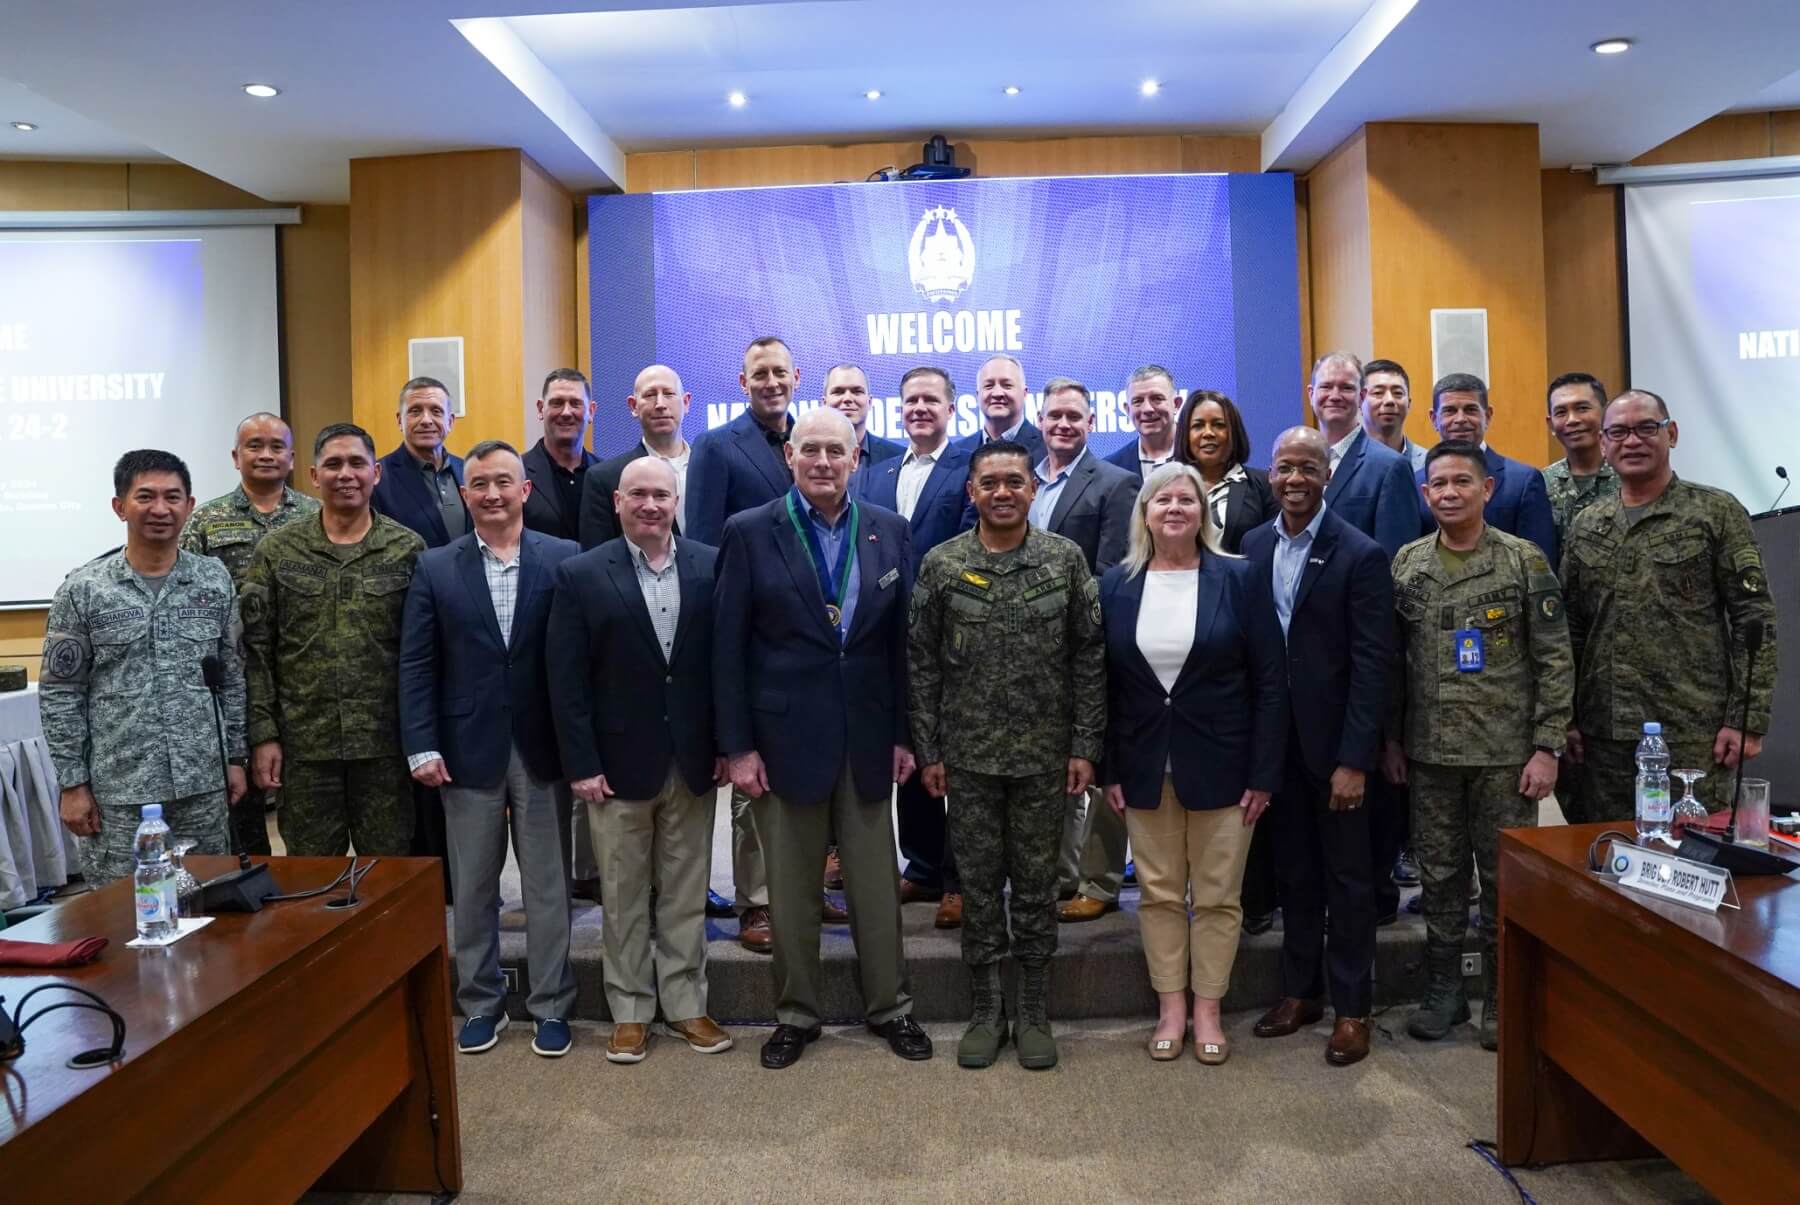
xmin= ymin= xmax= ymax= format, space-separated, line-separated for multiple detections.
xmin=1498 ymin=825 xmax=1800 ymax=1201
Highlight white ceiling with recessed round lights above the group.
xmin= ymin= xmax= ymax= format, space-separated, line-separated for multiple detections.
xmin=0 ymin=0 xmax=1800 ymax=202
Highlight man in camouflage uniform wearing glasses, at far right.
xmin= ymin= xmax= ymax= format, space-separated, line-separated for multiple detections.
xmin=1562 ymin=389 xmax=1775 ymax=821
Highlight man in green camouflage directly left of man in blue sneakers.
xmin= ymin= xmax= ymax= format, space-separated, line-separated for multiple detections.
xmin=243 ymin=423 xmax=425 ymax=856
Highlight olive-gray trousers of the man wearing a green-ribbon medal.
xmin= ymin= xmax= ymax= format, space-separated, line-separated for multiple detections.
xmin=751 ymin=764 xmax=913 ymax=1028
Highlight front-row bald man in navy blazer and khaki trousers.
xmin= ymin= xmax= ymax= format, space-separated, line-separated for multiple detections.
xmin=549 ymin=456 xmax=731 ymax=1063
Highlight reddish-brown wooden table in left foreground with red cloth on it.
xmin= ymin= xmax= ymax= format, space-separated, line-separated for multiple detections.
xmin=0 ymin=857 xmax=463 ymax=1203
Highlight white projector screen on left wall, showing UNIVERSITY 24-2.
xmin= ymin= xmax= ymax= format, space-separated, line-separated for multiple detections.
xmin=0 ymin=227 xmax=281 ymax=607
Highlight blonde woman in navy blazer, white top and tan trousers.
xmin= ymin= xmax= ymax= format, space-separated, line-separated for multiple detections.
xmin=1100 ymin=465 xmax=1287 ymax=1063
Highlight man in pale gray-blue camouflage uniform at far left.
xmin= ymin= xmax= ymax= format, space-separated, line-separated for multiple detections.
xmin=38 ymin=450 xmax=245 ymax=888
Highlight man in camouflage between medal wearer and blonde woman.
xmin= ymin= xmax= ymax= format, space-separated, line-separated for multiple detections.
xmin=907 ymin=439 xmax=1107 ymax=1068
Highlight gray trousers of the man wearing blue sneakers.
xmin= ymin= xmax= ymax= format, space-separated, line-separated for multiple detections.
xmin=443 ymin=747 xmax=574 ymax=1021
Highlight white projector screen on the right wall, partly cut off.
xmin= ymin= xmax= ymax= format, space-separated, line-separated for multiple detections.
xmin=1625 ymin=177 xmax=1800 ymax=513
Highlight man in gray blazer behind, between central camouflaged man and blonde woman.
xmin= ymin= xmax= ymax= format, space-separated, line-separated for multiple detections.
xmin=1031 ymin=376 xmax=1138 ymax=920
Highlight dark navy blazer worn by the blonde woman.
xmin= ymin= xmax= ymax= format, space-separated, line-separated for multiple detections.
xmin=1100 ymin=555 xmax=1287 ymax=811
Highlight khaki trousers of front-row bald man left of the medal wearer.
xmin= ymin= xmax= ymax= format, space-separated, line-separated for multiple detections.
xmin=585 ymin=766 xmax=718 ymax=1025
